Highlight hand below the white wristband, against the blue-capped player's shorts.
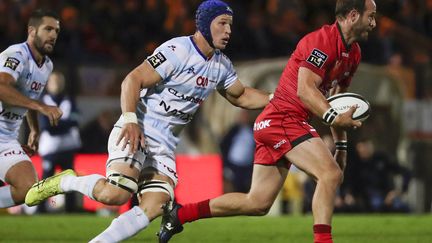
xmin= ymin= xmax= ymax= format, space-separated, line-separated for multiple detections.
xmin=116 ymin=123 xmax=145 ymax=154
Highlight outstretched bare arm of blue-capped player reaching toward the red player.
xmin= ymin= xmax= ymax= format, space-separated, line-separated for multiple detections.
xmin=219 ymin=79 xmax=270 ymax=109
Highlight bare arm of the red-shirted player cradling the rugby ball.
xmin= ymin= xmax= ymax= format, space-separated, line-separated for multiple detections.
xmin=297 ymin=67 xmax=361 ymax=129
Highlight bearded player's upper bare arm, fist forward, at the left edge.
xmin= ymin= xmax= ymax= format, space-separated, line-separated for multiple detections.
xmin=0 ymin=72 xmax=62 ymax=125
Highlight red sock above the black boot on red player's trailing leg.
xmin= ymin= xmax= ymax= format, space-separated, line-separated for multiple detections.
xmin=177 ymin=199 xmax=211 ymax=224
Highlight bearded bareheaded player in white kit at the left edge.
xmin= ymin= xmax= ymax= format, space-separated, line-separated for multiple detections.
xmin=0 ymin=10 xmax=62 ymax=208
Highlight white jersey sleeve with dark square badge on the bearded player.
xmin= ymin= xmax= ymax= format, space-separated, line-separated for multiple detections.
xmin=0 ymin=51 xmax=25 ymax=81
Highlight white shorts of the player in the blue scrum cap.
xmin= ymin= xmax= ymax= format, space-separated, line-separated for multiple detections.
xmin=106 ymin=125 xmax=178 ymax=185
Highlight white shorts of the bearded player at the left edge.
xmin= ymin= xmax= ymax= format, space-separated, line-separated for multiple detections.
xmin=0 ymin=140 xmax=31 ymax=181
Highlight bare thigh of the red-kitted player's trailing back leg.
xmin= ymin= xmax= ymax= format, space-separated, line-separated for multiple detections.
xmin=249 ymin=164 xmax=288 ymax=204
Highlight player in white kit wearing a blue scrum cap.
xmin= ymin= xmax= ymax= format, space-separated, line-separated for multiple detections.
xmin=26 ymin=0 xmax=270 ymax=242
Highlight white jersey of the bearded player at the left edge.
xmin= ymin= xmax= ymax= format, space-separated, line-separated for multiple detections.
xmin=0 ymin=42 xmax=53 ymax=143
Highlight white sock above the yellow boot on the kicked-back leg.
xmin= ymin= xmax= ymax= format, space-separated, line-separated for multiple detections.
xmin=60 ymin=174 xmax=105 ymax=200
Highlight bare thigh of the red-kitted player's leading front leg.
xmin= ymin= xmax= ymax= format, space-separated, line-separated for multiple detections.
xmin=285 ymin=137 xmax=340 ymax=178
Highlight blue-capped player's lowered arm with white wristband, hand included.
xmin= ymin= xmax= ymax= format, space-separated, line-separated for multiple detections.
xmin=117 ymin=61 xmax=162 ymax=153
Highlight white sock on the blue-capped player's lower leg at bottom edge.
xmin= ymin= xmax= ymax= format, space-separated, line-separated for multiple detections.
xmin=90 ymin=206 xmax=150 ymax=243
